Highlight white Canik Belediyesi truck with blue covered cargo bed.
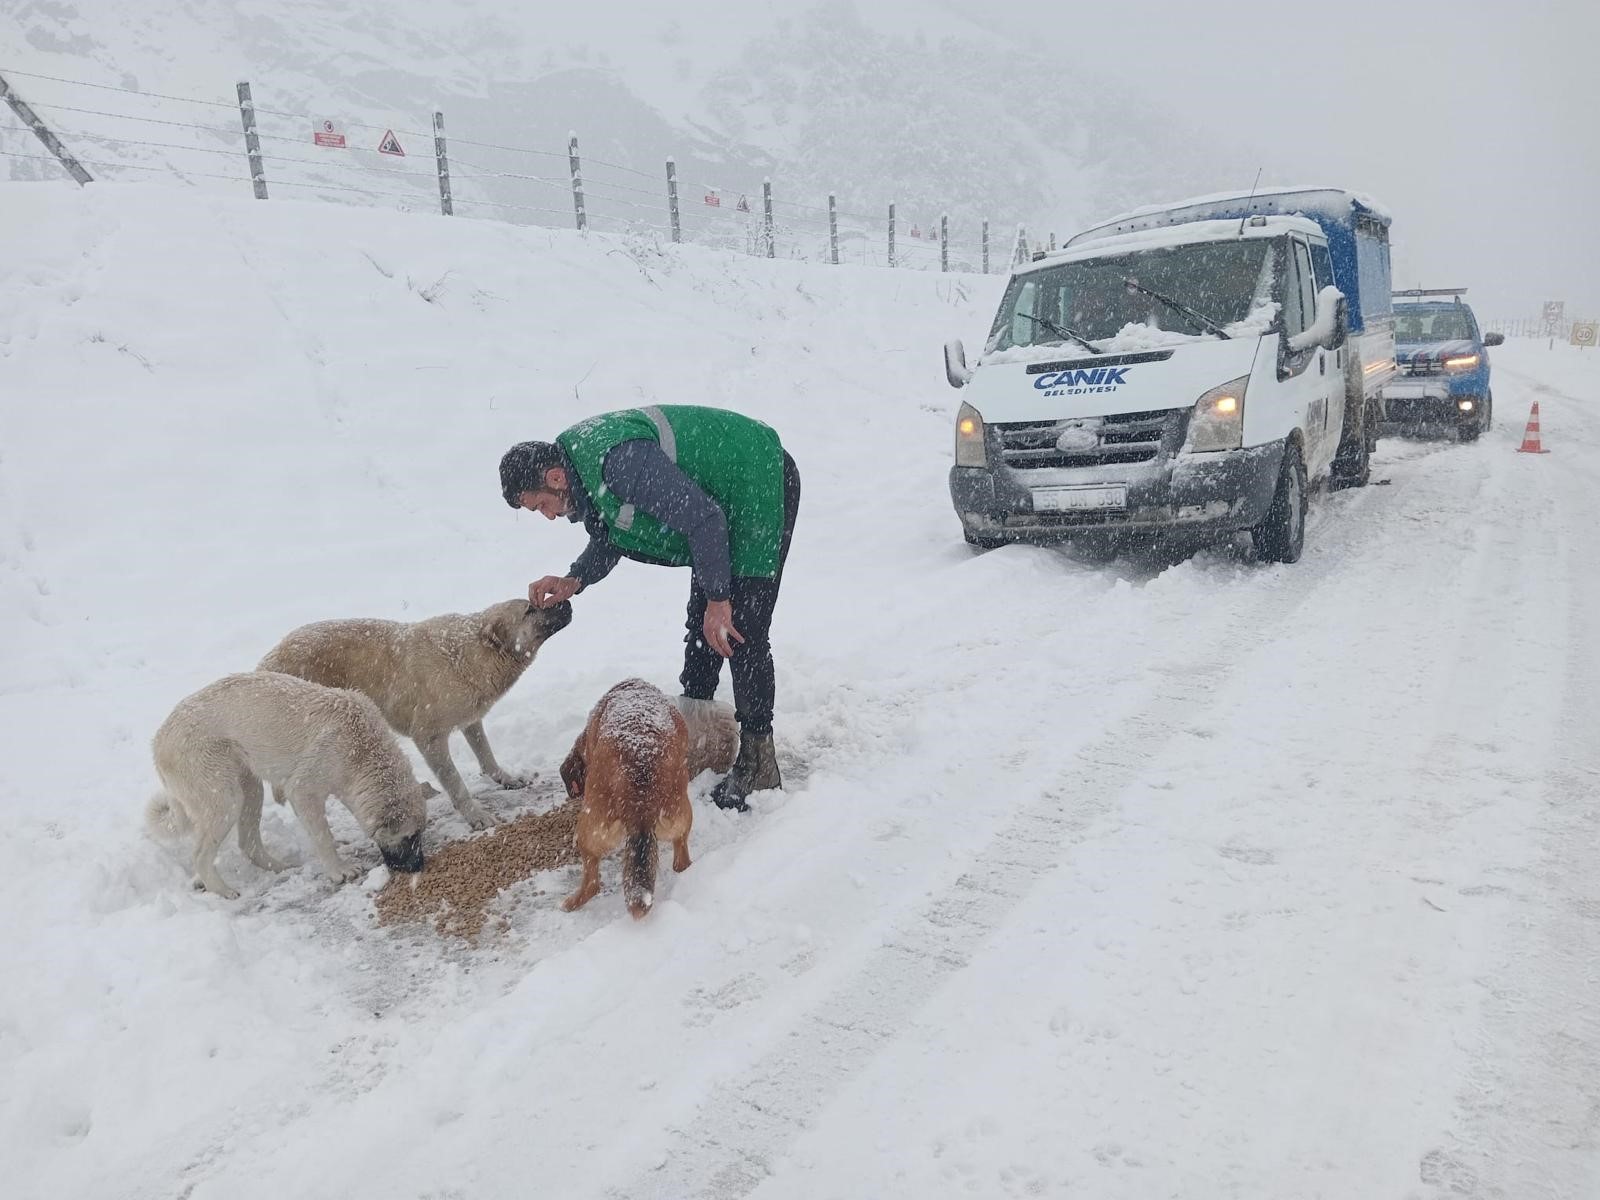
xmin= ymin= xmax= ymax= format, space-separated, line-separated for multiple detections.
xmin=946 ymin=189 xmax=1394 ymax=562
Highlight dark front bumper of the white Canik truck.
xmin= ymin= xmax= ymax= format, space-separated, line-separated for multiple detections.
xmin=950 ymin=442 xmax=1283 ymax=541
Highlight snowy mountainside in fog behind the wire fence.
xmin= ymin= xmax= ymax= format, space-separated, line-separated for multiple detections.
xmin=0 ymin=0 xmax=1256 ymax=246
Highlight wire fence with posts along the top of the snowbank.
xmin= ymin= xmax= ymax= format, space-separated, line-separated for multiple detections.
xmin=0 ymin=66 xmax=1030 ymax=272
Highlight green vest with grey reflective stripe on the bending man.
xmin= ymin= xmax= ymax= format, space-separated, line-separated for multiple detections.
xmin=555 ymin=405 xmax=784 ymax=579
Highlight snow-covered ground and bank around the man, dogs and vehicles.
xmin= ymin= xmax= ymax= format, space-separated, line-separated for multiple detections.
xmin=0 ymin=186 xmax=1600 ymax=1200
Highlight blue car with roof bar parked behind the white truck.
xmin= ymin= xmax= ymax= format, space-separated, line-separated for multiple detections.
xmin=1384 ymin=288 xmax=1506 ymax=442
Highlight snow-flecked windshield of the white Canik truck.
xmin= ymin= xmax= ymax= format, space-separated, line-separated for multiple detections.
xmin=989 ymin=238 xmax=1280 ymax=350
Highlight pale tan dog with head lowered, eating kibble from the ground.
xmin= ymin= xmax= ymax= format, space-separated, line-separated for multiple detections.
xmin=147 ymin=672 xmax=438 ymax=899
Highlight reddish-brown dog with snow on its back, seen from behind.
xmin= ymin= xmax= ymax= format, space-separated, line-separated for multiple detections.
xmin=562 ymin=678 xmax=694 ymax=920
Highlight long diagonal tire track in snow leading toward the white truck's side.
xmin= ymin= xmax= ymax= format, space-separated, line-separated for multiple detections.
xmin=608 ymin=490 xmax=1376 ymax=1200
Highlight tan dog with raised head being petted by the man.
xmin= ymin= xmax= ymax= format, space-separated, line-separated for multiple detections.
xmin=261 ymin=600 xmax=573 ymax=829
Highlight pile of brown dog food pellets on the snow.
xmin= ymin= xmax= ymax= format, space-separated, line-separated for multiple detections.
xmin=376 ymin=802 xmax=578 ymax=939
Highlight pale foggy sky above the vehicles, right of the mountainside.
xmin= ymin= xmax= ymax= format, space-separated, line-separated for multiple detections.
xmin=947 ymin=0 xmax=1600 ymax=318
